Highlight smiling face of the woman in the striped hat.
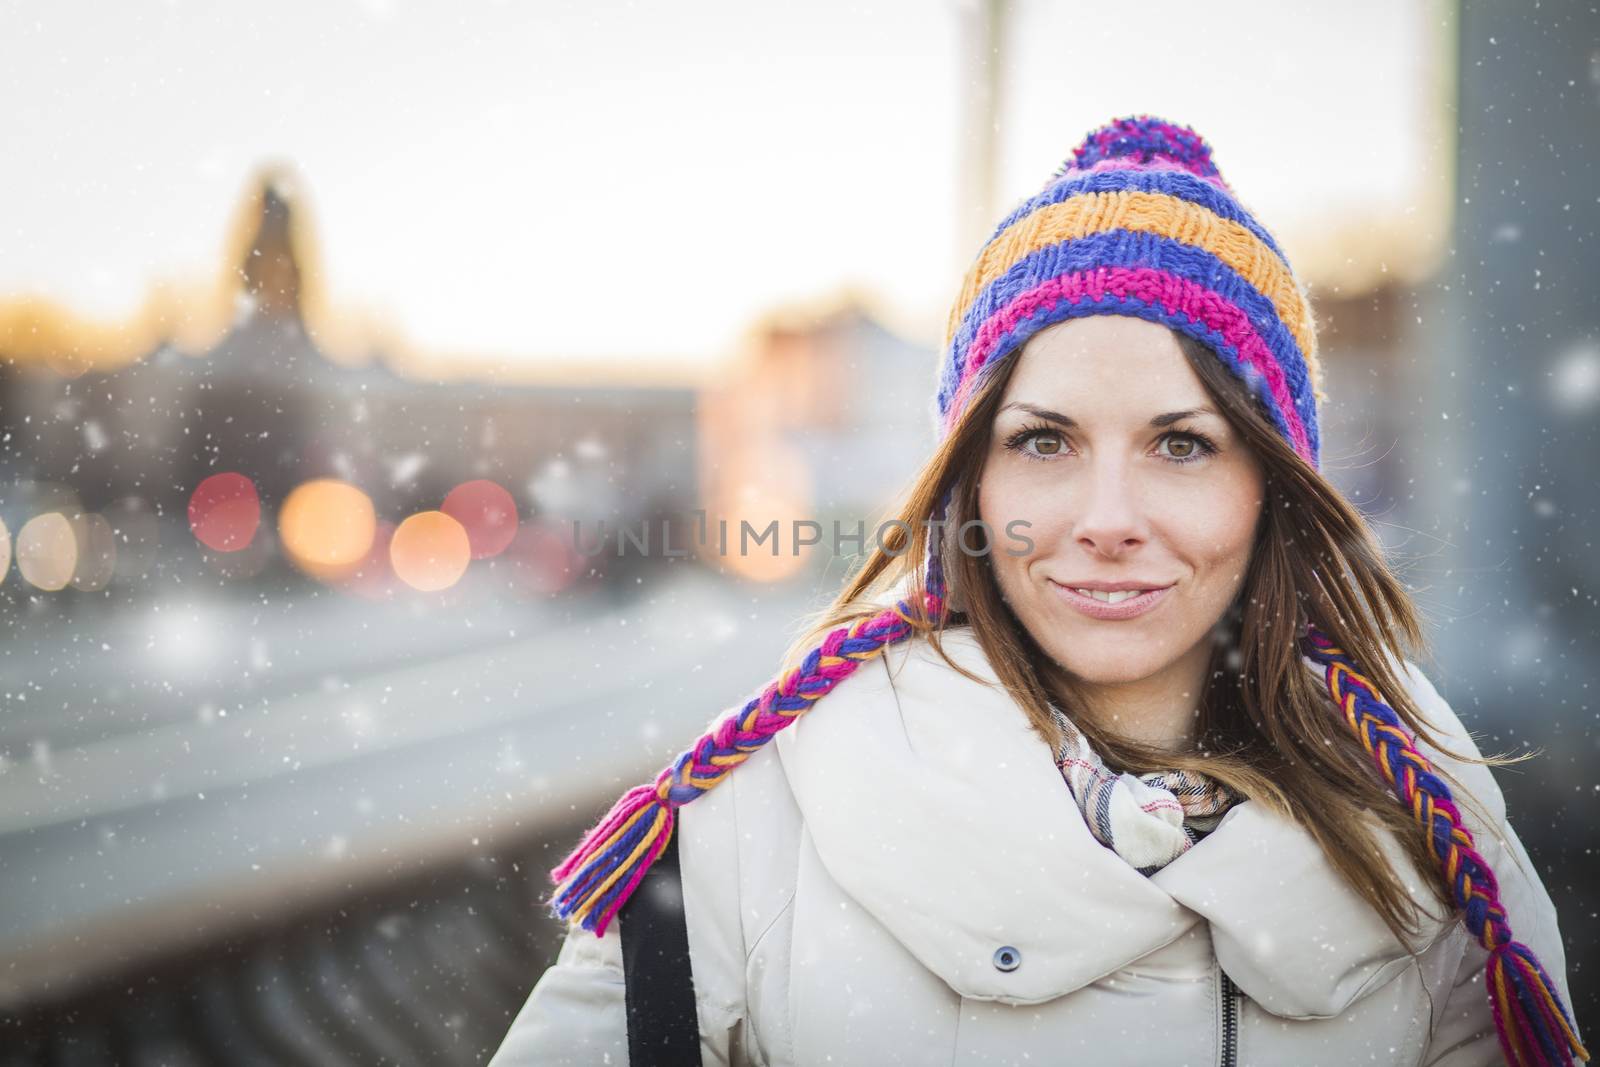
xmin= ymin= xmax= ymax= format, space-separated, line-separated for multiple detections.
xmin=978 ymin=315 xmax=1264 ymax=688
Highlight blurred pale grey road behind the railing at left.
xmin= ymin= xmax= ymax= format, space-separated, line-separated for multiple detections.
xmin=0 ymin=568 xmax=813 ymax=1005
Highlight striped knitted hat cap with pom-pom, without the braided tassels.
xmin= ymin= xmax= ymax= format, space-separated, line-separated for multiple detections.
xmin=938 ymin=117 xmax=1323 ymax=467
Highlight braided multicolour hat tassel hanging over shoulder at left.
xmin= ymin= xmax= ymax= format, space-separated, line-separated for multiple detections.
xmin=550 ymin=590 xmax=942 ymax=937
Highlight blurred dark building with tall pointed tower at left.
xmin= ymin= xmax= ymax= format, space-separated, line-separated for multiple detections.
xmin=0 ymin=171 xmax=698 ymax=598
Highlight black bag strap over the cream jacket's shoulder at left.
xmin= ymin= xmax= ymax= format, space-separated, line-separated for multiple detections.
xmin=618 ymin=827 xmax=701 ymax=1067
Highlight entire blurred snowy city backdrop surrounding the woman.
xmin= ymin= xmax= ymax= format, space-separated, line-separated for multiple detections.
xmin=0 ymin=0 xmax=1600 ymax=1064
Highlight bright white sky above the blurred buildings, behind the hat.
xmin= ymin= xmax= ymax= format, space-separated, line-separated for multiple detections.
xmin=0 ymin=0 xmax=1453 ymax=369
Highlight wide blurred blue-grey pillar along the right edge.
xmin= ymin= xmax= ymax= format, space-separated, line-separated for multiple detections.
xmin=1411 ymin=0 xmax=1600 ymax=1023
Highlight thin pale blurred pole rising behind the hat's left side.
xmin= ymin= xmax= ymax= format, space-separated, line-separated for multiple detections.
xmin=957 ymin=0 xmax=1011 ymax=257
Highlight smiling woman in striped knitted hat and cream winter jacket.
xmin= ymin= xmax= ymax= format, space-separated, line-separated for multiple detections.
xmin=494 ymin=117 xmax=1587 ymax=1067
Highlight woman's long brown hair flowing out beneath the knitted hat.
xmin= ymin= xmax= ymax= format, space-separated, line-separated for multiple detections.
xmin=784 ymin=327 xmax=1531 ymax=944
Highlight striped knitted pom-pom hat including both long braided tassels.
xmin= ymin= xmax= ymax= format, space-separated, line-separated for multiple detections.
xmin=549 ymin=115 xmax=1589 ymax=1067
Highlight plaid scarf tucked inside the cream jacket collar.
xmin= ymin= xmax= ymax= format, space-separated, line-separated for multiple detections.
xmin=1050 ymin=705 xmax=1240 ymax=875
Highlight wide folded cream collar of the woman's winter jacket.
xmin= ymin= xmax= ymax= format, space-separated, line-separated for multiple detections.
xmin=776 ymin=627 xmax=1445 ymax=1017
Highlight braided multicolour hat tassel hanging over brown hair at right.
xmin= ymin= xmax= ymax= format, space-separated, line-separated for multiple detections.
xmin=1304 ymin=625 xmax=1589 ymax=1067
